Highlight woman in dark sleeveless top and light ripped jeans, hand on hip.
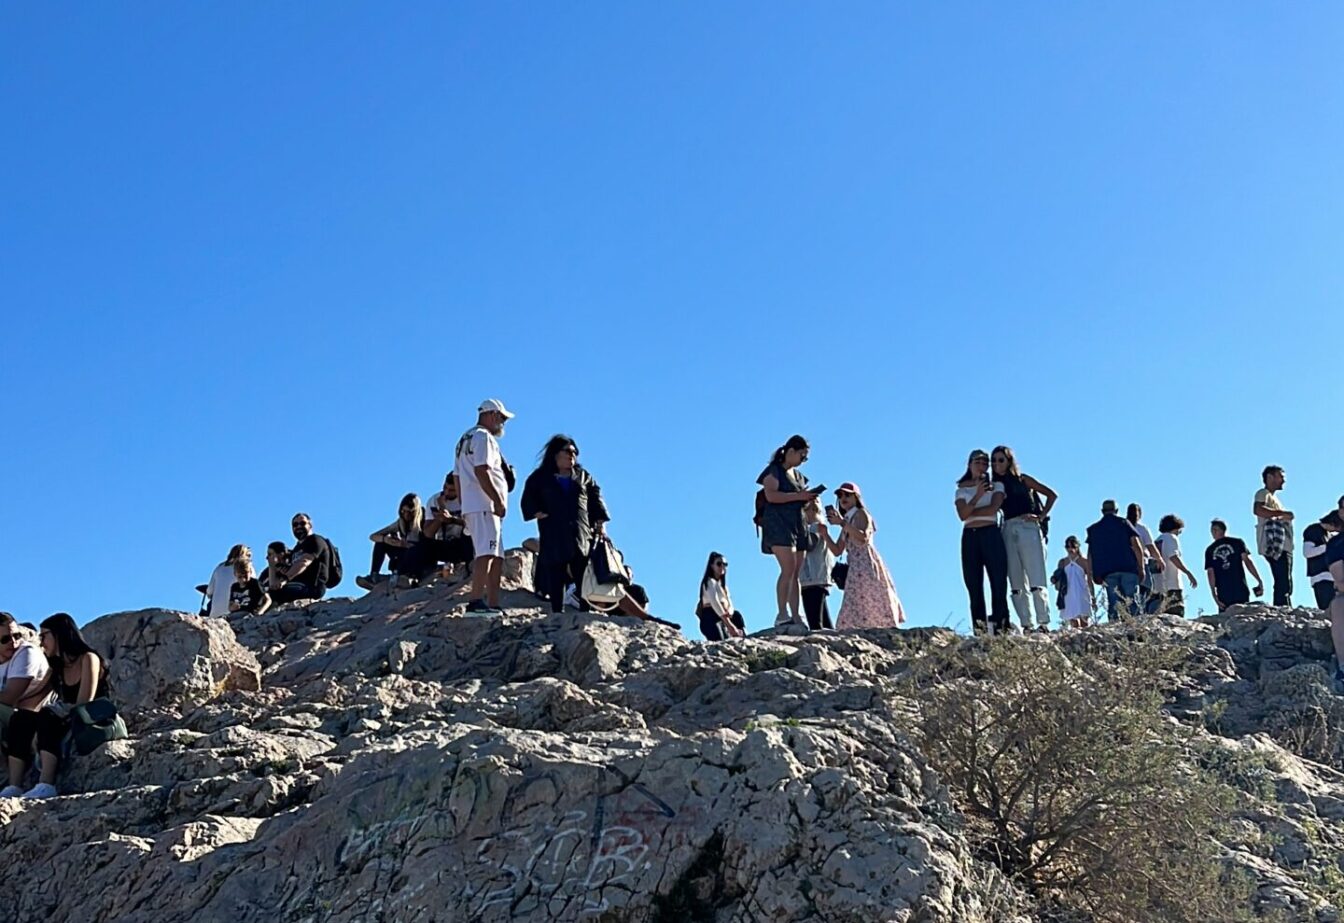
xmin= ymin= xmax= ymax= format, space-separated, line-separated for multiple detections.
xmin=989 ymin=446 xmax=1059 ymax=631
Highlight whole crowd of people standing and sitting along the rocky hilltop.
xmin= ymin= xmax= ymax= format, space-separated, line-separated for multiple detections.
xmin=0 ymin=399 xmax=1344 ymax=798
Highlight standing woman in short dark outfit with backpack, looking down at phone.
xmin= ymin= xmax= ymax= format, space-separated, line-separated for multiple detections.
xmin=757 ymin=435 xmax=821 ymax=625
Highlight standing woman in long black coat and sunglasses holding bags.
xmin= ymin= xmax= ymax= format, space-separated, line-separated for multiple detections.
xmin=523 ymin=434 xmax=612 ymax=613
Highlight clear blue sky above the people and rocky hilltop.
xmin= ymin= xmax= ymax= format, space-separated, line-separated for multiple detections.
xmin=0 ymin=3 xmax=1344 ymax=634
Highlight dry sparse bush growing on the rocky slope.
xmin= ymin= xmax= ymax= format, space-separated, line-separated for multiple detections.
xmin=906 ymin=641 xmax=1250 ymax=923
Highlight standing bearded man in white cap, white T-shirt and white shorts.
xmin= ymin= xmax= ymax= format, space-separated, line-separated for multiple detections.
xmin=454 ymin=398 xmax=513 ymax=614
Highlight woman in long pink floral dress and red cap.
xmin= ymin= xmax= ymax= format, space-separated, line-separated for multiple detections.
xmin=827 ymin=481 xmax=906 ymax=630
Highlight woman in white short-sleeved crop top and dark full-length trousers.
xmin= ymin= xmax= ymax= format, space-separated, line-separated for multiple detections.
xmin=956 ymin=449 xmax=1009 ymax=634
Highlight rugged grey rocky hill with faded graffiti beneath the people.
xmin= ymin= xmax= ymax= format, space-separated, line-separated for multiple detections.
xmin=0 ymin=552 xmax=1344 ymax=923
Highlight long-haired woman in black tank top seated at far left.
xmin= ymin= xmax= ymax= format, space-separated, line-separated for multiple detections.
xmin=5 ymin=613 xmax=108 ymax=798
